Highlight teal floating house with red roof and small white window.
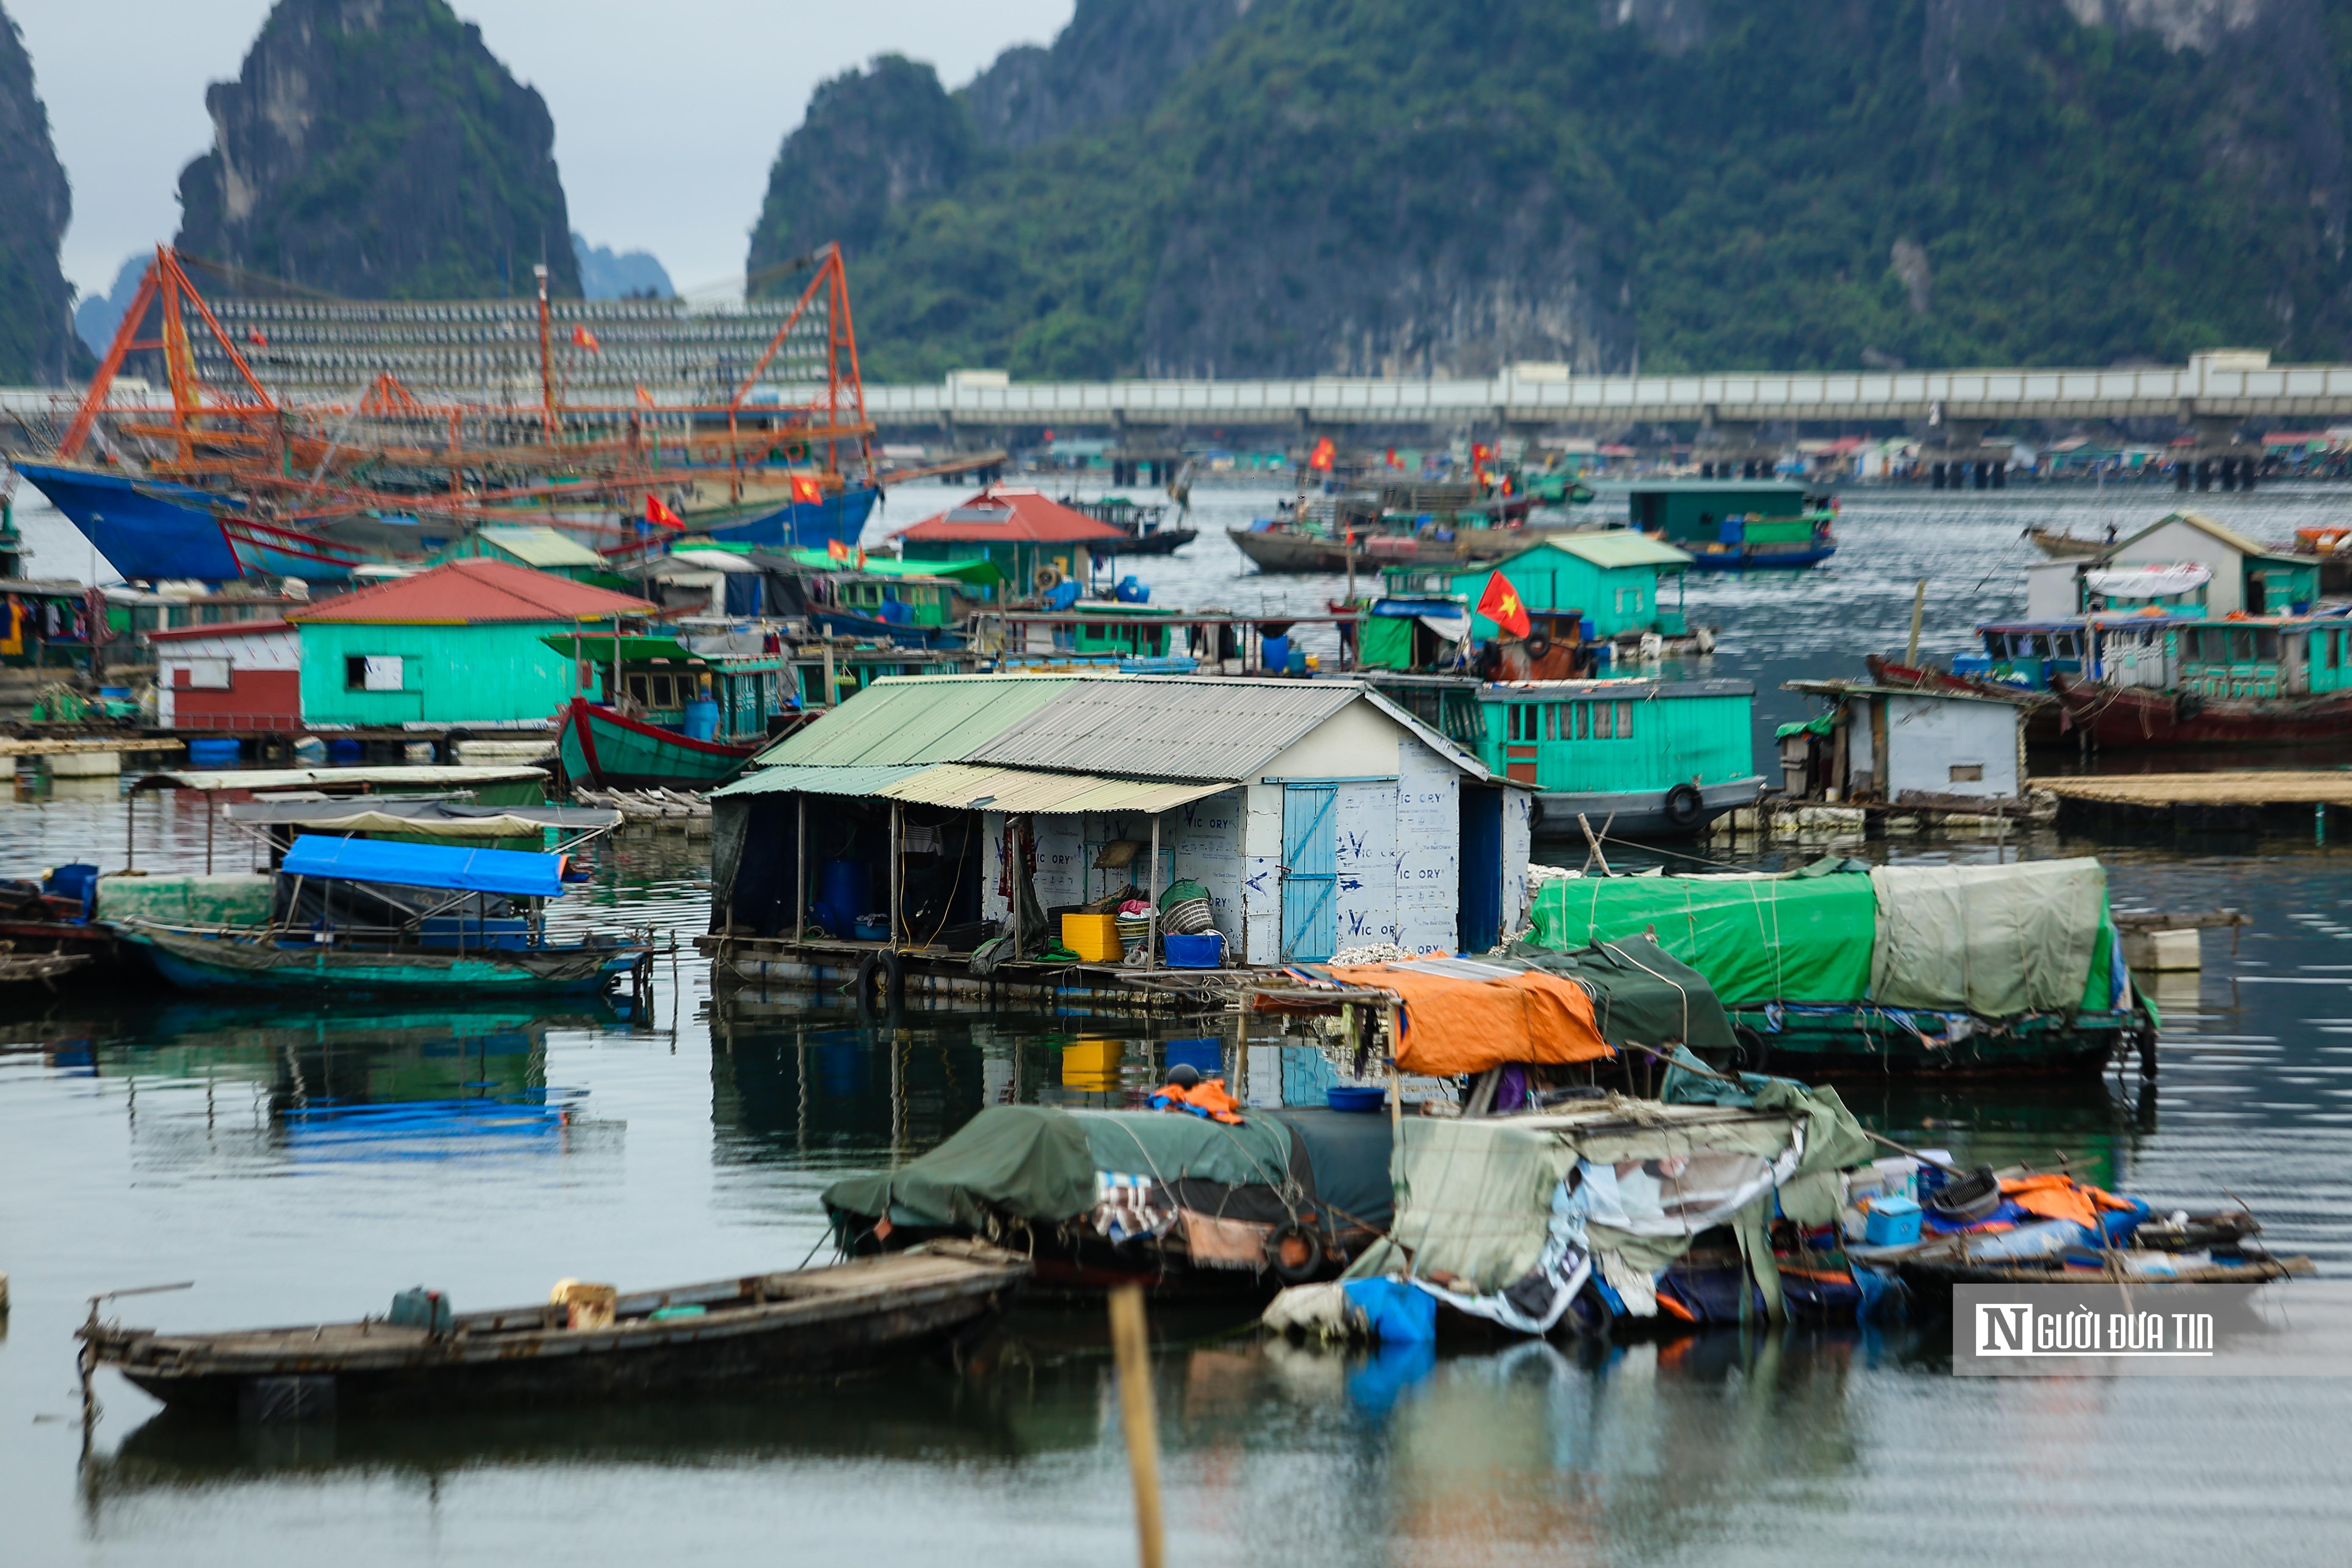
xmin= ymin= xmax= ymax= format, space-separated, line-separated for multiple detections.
xmin=287 ymin=560 xmax=654 ymax=729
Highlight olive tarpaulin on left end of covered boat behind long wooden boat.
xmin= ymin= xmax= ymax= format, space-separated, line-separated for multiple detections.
xmin=825 ymin=1105 xmax=1096 ymax=1234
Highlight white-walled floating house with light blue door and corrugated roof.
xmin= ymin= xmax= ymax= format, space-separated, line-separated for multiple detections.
xmin=713 ymin=674 xmax=1529 ymax=980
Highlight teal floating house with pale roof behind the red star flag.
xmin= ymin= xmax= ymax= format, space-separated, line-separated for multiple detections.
xmin=1364 ymin=529 xmax=1691 ymax=649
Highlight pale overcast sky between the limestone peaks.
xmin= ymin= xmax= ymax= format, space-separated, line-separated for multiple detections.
xmin=0 ymin=0 xmax=1072 ymax=291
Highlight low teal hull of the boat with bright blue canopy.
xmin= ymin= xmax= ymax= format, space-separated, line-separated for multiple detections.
xmin=120 ymin=921 xmax=644 ymax=994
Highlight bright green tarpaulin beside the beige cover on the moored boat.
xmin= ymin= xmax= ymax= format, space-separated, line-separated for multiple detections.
xmin=1536 ymin=870 xmax=1877 ymax=1008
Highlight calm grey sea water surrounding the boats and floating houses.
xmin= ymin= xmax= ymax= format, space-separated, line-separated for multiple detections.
xmin=0 ymin=489 xmax=2352 ymax=1568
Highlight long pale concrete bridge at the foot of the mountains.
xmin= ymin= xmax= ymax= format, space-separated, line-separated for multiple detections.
xmin=866 ymin=350 xmax=2352 ymax=447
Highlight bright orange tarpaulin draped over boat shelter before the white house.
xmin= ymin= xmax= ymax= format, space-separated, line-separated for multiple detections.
xmin=1331 ymin=964 xmax=1611 ymax=1077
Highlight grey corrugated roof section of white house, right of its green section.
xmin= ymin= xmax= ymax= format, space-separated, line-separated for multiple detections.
xmin=962 ymin=680 xmax=1364 ymax=783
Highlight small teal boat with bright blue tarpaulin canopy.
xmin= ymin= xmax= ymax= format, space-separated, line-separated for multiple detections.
xmin=111 ymin=818 xmax=652 ymax=992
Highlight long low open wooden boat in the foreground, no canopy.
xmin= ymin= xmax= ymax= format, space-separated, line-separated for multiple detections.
xmin=78 ymin=1241 xmax=1030 ymax=1418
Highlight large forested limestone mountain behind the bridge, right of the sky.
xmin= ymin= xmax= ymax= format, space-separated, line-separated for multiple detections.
xmin=753 ymin=0 xmax=2352 ymax=376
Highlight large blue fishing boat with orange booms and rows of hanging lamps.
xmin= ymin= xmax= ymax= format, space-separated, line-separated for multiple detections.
xmin=21 ymin=244 xmax=875 ymax=576
